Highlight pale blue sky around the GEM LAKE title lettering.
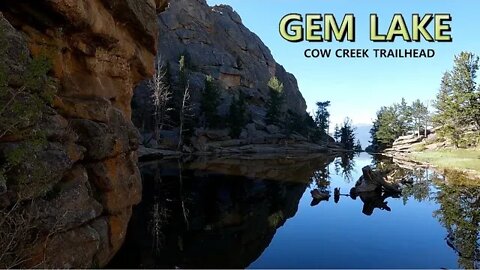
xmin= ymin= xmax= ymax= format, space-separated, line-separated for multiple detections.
xmin=207 ymin=0 xmax=480 ymax=124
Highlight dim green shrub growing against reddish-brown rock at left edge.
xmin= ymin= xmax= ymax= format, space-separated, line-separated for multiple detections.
xmin=0 ymin=24 xmax=55 ymax=194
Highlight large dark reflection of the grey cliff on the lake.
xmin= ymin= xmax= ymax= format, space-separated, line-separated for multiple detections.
xmin=111 ymin=154 xmax=332 ymax=268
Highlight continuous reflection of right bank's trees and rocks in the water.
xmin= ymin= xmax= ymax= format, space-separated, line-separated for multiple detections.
xmin=373 ymin=157 xmax=480 ymax=269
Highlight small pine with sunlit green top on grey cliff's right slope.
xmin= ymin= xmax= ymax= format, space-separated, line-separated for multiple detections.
xmin=266 ymin=77 xmax=283 ymax=125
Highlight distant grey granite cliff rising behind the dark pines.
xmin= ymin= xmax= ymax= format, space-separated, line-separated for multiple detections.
xmin=133 ymin=0 xmax=306 ymax=135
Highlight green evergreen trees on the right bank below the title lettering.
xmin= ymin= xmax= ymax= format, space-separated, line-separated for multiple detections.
xmin=369 ymin=52 xmax=480 ymax=151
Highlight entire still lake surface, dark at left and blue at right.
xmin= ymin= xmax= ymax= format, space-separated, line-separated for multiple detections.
xmin=110 ymin=154 xmax=480 ymax=268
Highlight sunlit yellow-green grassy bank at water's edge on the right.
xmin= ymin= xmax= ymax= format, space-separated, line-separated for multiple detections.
xmin=410 ymin=149 xmax=480 ymax=175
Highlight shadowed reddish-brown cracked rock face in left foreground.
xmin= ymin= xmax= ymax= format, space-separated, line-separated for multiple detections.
xmin=0 ymin=0 xmax=166 ymax=268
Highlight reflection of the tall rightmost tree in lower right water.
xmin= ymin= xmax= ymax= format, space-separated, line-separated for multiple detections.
xmin=434 ymin=172 xmax=480 ymax=269
